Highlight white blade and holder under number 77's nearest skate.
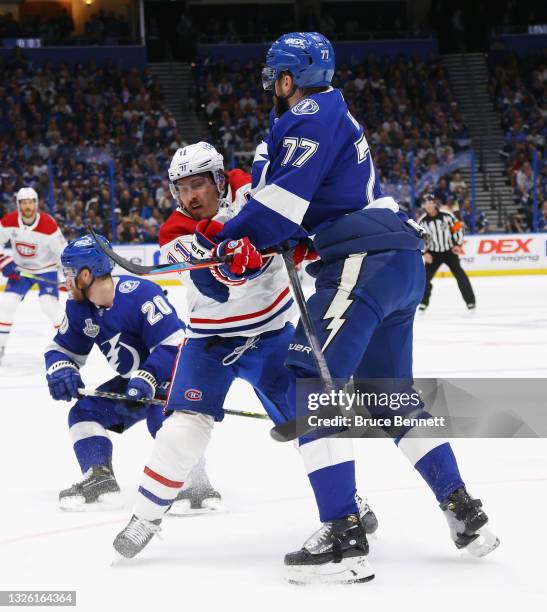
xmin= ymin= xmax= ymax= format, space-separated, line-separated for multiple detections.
xmin=285 ymin=556 xmax=375 ymax=584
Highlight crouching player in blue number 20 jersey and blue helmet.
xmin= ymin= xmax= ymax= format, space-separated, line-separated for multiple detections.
xmin=45 ymin=236 xmax=220 ymax=513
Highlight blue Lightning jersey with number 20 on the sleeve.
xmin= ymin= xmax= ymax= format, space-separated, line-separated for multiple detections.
xmin=45 ymin=276 xmax=184 ymax=382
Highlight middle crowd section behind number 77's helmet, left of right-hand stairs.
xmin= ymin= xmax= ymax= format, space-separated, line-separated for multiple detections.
xmin=195 ymin=57 xmax=482 ymax=225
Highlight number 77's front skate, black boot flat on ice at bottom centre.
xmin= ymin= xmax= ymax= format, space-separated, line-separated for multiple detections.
xmin=285 ymin=514 xmax=374 ymax=584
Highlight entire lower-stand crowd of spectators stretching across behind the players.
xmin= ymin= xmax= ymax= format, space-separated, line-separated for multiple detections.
xmin=0 ymin=46 xmax=547 ymax=243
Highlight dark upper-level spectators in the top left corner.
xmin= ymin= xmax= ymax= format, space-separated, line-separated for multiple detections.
xmin=0 ymin=9 xmax=131 ymax=46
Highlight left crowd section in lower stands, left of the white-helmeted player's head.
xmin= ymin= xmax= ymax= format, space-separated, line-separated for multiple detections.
xmin=0 ymin=54 xmax=185 ymax=242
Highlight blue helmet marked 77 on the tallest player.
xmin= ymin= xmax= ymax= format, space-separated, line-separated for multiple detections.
xmin=262 ymin=32 xmax=334 ymax=90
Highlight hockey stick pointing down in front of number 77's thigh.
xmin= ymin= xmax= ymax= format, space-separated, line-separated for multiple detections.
xmin=270 ymin=248 xmax=338 ymax=442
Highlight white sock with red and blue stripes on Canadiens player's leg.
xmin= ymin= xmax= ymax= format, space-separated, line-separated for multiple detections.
xmin=134 ymin=411 xmax=214 ymax=521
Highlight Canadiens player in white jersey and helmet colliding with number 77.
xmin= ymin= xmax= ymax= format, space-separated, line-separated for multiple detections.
xmin=114 ymin=142 xmax=377 ymax=577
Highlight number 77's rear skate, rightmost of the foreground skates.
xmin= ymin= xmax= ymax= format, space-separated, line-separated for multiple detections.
xmin=440 ymin=488 xmax=500 ymax=557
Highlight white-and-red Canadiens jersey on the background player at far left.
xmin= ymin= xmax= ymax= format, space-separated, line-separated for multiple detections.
xmin=0 ymin=211 xmax=66 ymax=274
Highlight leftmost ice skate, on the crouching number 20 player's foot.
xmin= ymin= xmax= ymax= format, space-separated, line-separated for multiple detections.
xmin=59 ymin=465 xmax=123 ymax=512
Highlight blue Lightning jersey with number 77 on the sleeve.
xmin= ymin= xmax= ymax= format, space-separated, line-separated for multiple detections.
xmin=219 ymin=88 xmax=390 ymax=248
